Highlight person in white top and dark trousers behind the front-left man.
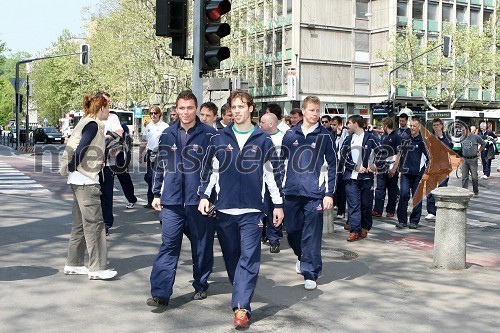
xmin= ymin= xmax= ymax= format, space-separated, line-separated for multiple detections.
xmin=139 ymin=105 xmax=168 ymax=209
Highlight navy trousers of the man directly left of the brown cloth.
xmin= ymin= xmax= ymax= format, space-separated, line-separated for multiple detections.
xmin=398 ymin=174 xmax=422 ymax=224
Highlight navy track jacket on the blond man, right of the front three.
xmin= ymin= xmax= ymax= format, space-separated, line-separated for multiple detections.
xmin=282 ymin=122 xmax=337 ymax=199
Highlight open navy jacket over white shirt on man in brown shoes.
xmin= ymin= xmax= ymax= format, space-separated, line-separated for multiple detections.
xmin=339 ymin=131 xmax=390 ymax=180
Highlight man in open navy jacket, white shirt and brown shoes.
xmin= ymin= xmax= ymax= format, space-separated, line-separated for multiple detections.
xmin=339 ymin=115 xmax=383 ymax=242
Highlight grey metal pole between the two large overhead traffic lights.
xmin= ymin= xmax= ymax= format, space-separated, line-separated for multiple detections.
xmin=192 ymin=0 xmax=204 ymax=105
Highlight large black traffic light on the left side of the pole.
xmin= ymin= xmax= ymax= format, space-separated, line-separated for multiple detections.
xmin=154 ymin=0 xmax=188 ymax=58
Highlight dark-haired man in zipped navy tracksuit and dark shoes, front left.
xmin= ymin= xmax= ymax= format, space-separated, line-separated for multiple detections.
xmin=147 ymin=91 xmax=216 ymax=306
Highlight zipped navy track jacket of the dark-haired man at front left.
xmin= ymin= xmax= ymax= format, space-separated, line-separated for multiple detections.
xmin=153 ymin=117 xmax=217 ymax=205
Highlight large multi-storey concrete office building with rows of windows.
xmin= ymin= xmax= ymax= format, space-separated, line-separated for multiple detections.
xmin=215 ymin=0 xmax=498 ymax=122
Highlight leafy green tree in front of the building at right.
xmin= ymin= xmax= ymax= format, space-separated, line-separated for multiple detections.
xmin=382 ymin=22 xmax=498 ymax=109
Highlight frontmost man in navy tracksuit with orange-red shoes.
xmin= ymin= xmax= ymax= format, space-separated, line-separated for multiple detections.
xmin=198 ymin=90 xmax=283 ymax=329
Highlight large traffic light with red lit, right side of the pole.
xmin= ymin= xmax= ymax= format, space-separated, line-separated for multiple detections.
xmin=201 ymin=0 xmax=231 ymax=71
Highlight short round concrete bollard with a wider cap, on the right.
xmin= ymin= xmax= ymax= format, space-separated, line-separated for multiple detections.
xmin=432 ymin=186 xmax=472 ymax=269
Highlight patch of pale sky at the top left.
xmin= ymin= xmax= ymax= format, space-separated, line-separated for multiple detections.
xmin=0 ymin=0 xmax=102 ymax=55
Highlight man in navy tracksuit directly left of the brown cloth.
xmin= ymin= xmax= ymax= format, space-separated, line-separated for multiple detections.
xmin=396 ymin=118 xmax=429 ymax=229
